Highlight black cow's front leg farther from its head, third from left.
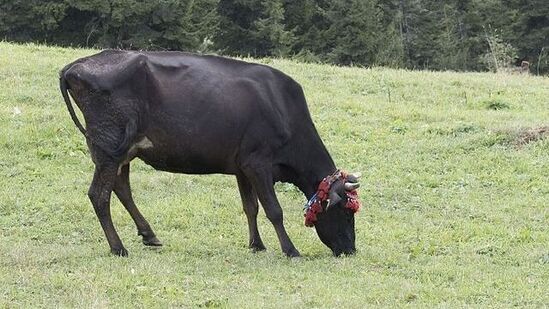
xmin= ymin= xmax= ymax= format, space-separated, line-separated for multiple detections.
xmin=236 ymin=175 xmax=265 ymax=252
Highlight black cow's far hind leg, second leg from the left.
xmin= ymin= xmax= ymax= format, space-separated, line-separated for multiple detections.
xmin=114 ymin=164 xmax=162 ymax=246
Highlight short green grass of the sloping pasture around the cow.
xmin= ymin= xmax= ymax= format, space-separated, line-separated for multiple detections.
xmin=0 ymin=43 xmax=549 ymax=308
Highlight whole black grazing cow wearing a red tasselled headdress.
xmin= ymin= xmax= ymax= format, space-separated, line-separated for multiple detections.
xmin=60 ymin=50 xmax=358 ymax=257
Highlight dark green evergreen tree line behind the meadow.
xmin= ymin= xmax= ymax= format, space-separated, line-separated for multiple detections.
xmin=0 ymin=0 xmax=549 ymax=74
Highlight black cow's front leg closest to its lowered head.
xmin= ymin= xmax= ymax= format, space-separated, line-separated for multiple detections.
xmin=245 ymin=167 xmax=300 ymax=257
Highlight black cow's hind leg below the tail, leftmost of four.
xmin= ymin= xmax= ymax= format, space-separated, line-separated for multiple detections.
xmin=88 ymin=164 xmax=128 ymax=256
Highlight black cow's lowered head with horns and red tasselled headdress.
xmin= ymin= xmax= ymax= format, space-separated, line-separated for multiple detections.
xmin=306 ymin=174 xmax=359 ymax=256
